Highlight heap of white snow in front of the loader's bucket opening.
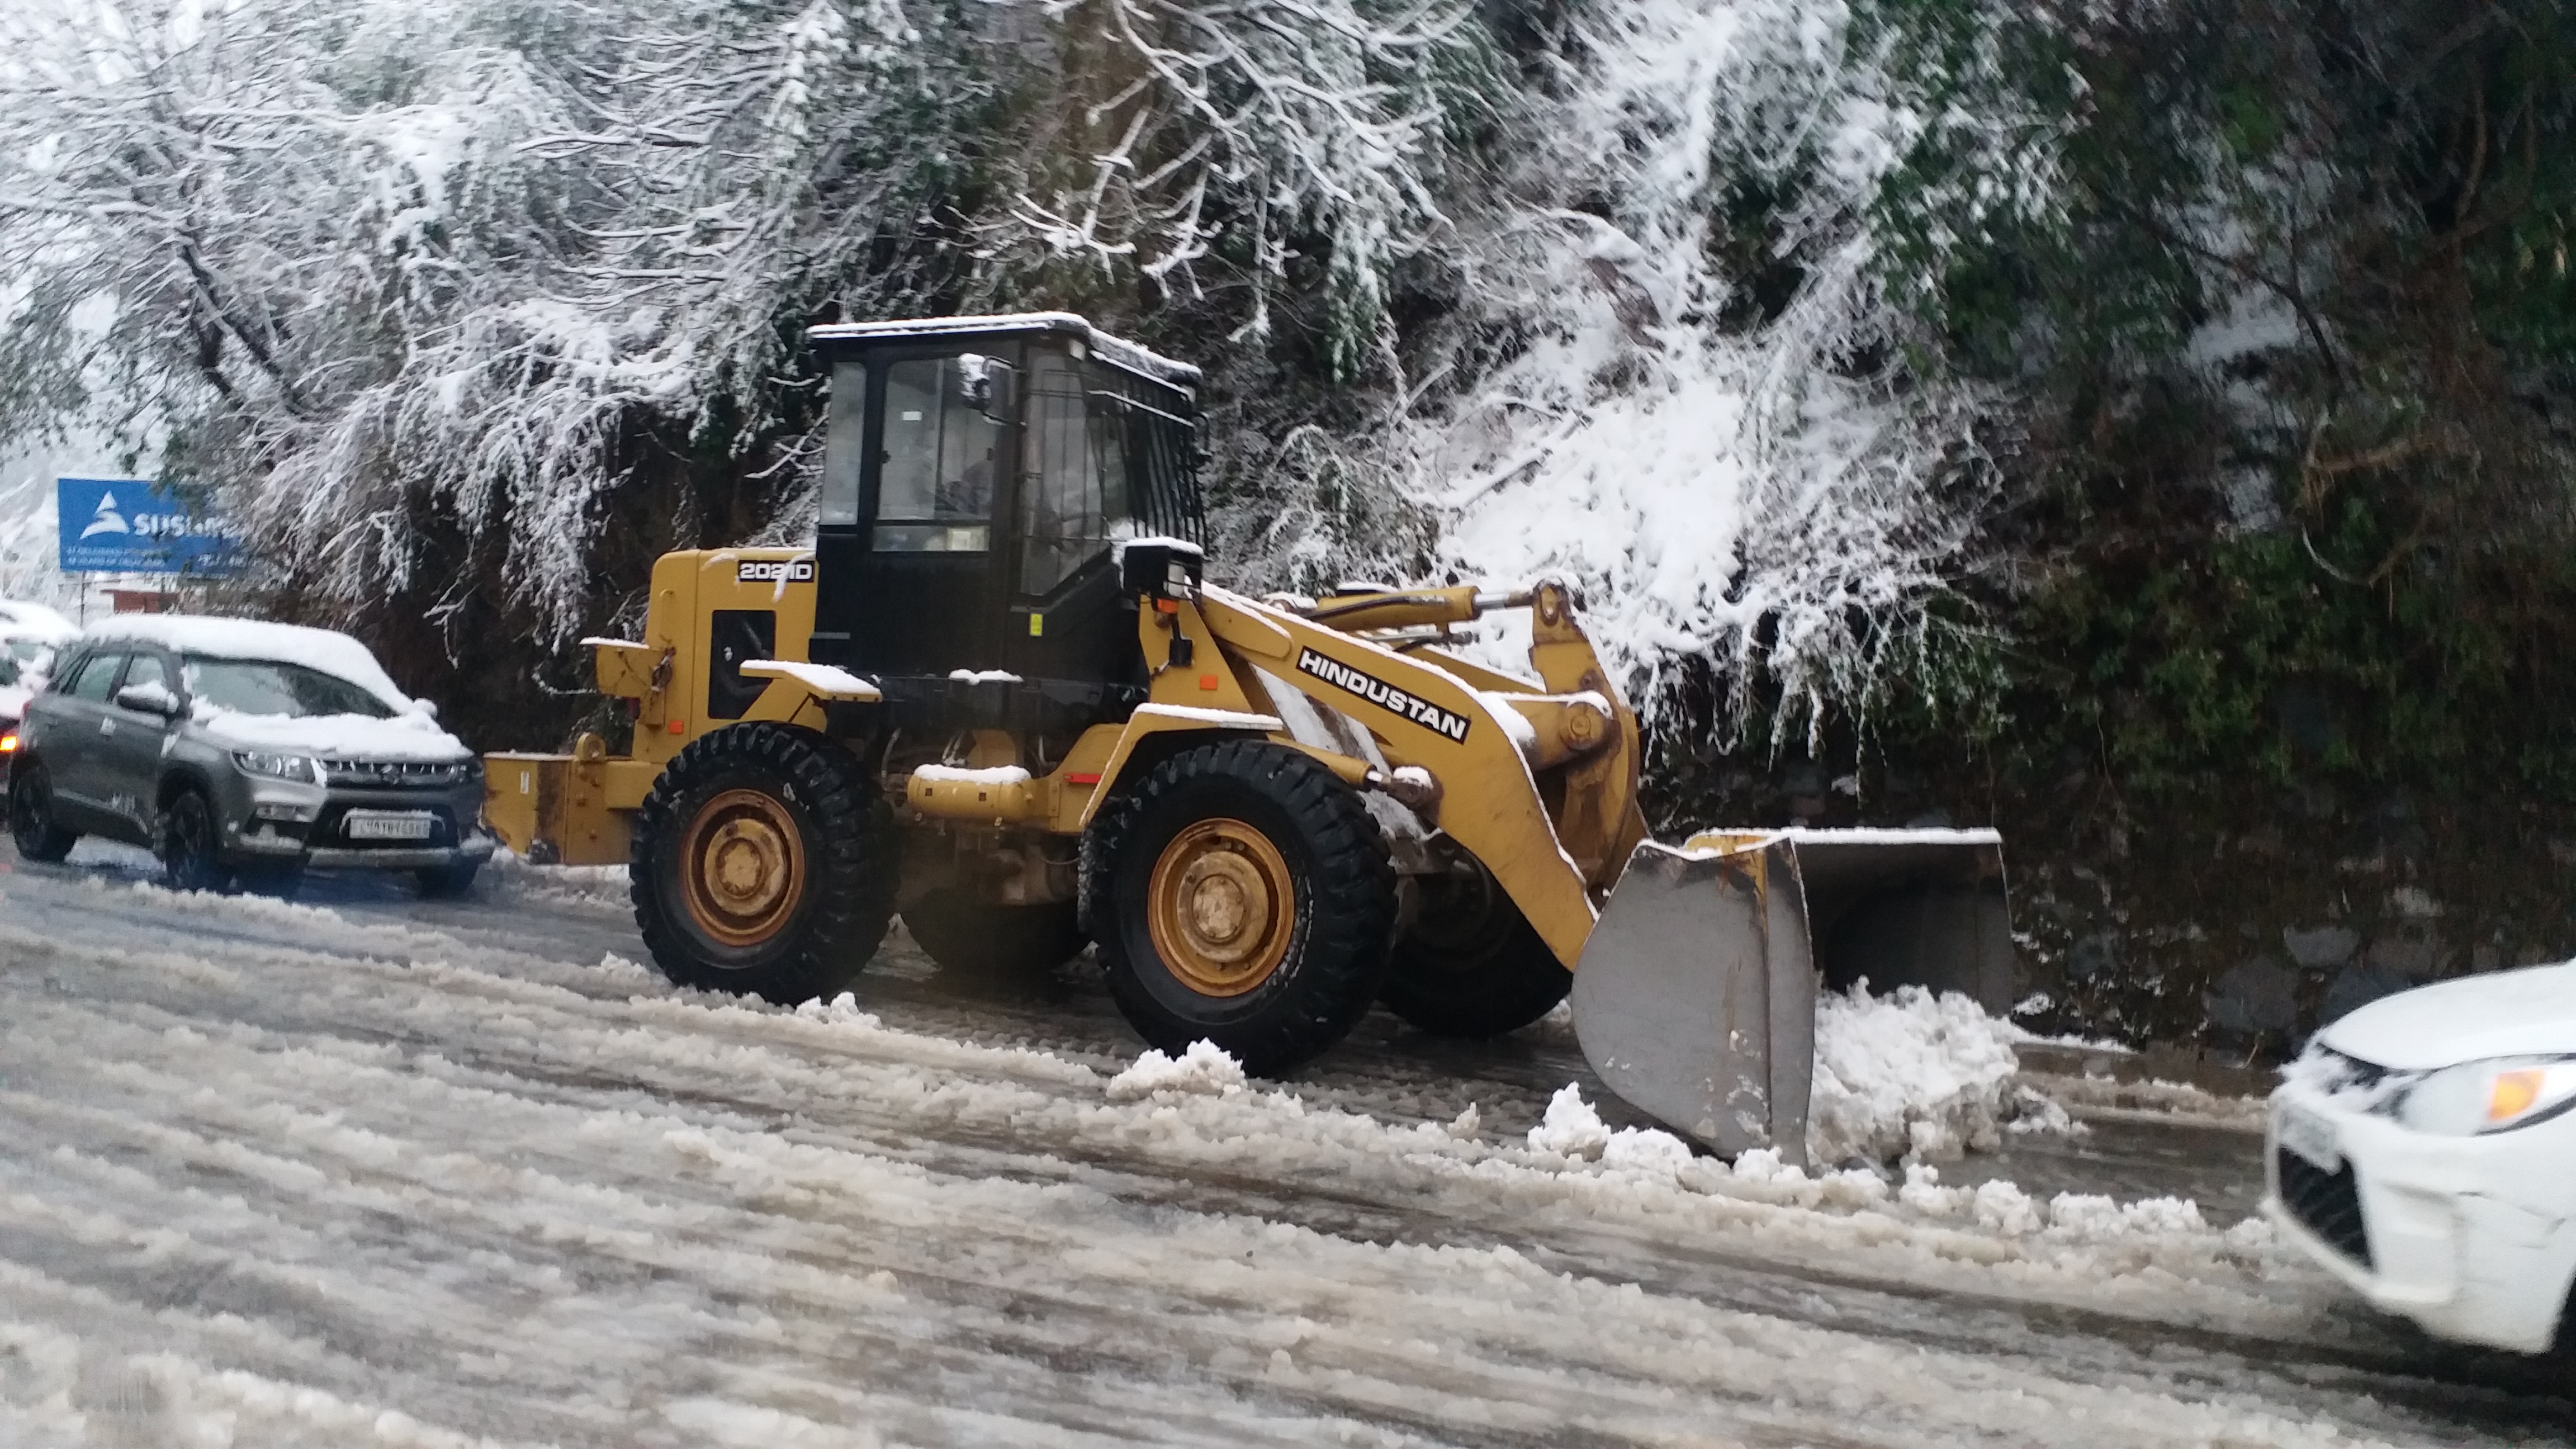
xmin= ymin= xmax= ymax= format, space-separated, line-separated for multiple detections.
xmin=1806 ymin=987 xmax=2063 ymax=1163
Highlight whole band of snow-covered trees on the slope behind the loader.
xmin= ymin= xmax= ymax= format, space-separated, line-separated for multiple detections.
xmin=0 ymin=0 xmax=2048 ymax=742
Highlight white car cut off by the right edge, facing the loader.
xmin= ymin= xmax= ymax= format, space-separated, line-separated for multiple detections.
xmin=2264 ymin=962 xmax=2576 ymax=1353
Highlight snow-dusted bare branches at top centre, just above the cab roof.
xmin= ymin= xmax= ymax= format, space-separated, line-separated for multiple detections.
xmin=989 ymin=0 xmax=1494 ymax=374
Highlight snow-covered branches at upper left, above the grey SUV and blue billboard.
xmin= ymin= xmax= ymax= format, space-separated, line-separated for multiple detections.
xmin=0 ymin=0 xmax=948 ymax=632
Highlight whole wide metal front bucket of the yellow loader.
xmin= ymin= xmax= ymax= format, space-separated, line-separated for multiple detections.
xmin=1569 ymin=830 xmax=2012 ymax=1166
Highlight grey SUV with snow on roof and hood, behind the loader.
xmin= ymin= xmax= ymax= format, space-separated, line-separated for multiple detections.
xmin=8 ymin=616 xmax=492 ymax=897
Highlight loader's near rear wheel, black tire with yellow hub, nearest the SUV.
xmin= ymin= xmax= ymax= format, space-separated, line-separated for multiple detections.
xmin=628 ymin=722 xmax=897 ymax=1006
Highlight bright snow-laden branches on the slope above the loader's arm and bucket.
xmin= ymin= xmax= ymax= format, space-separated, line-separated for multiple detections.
xmin=1409 ymin=0 xmax=2053 ymax=730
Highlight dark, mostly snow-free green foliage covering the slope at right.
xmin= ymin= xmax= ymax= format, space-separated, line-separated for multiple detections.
xmin=1834 ymin=0 xmax=2576 ymax=815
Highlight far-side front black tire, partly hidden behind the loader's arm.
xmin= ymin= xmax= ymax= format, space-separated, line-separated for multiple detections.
xmin=1378 ymin=861 xmax=1574 ymax=1041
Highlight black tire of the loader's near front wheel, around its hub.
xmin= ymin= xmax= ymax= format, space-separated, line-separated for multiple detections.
xmin=1082 ymin=740 xmax=1396 ymax=1075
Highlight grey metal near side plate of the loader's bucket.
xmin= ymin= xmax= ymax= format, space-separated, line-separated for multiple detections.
xmin=1569 ymin=835 xmax=1816 ymax=1166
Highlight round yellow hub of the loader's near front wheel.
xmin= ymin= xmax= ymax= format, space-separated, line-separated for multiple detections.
xmin=1147 ymin=820 xmax=1296 ymax=995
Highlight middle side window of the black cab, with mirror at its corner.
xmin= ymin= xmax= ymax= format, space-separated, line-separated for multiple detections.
xmin=873 ymin=353 xmax=1002 ymax=555
